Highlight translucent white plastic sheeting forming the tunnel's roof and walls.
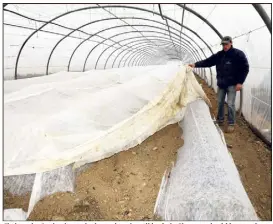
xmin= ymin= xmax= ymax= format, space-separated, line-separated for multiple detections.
xmin=4 ymin=4 xmax=272 ymax=143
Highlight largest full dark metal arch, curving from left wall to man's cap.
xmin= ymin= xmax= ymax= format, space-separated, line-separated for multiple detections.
xmin=12 ymin=5 xmax=218 ymax=79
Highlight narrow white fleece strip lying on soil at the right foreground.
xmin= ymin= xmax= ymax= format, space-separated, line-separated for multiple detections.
xmin=154 ymin=100 xmax=259 ymax=221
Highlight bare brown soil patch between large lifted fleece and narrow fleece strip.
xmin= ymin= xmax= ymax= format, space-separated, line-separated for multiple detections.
xmin=29 ymin=124 xmax=183 ymax=220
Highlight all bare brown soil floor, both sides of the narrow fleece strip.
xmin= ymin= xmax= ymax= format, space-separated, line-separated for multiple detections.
xmin=4 ymin=75 xmax=272 ymax=221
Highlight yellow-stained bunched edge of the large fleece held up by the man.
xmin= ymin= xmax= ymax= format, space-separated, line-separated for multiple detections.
xmin=5 ymin=66 xmax=211 ymax=175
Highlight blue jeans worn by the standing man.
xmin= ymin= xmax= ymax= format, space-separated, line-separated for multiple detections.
xmin=217 ymin=86 xmax=236 ymax=125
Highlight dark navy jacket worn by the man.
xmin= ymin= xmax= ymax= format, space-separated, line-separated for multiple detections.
xmin=195 ymin=47 xmax=249 ymax=88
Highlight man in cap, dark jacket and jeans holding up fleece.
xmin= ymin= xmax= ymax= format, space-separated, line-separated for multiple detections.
xmin=189 ymin=36 xmax=249 ymax=133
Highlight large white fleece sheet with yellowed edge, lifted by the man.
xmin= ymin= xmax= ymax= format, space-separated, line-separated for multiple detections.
xmin=4 ymin=64 xmax=209 ymax=176
